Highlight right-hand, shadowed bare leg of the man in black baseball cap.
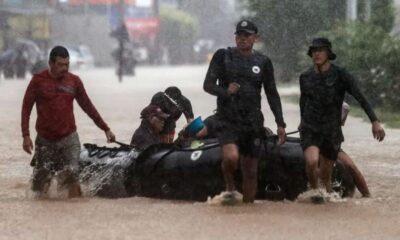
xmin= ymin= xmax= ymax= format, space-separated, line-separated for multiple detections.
xmin=241 ymin=156 xmax=257 ymax=203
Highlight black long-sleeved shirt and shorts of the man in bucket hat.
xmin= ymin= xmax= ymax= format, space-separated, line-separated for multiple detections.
xmin=300 ymin=64 xmax=377 ymax=160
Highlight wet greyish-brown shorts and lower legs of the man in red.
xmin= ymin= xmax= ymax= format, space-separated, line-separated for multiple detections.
xmin=31 ymin=132 xmax=81 ymax=192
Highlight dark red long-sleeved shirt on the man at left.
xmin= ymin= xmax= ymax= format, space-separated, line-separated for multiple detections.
xmin=21 ymin=70 xmax=109 ymax=140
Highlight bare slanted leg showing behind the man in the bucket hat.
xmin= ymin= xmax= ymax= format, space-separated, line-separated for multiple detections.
xmin=338 ymin=151 xmax=371 ymax=197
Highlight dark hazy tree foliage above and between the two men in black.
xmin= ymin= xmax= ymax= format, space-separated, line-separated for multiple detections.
xmin=241 ymin=0 xmax=394 ymax=81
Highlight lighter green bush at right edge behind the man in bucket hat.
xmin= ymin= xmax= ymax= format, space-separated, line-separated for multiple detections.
xmin=323 ymin=21 xmax=400 ymax=111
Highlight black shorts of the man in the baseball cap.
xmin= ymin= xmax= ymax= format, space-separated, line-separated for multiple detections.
xmin=218 ymin=124 xmax=264 ymax=157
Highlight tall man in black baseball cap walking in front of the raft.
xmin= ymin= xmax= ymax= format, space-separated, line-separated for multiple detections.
xmin=204 ymin=20 xmax=286 ymax=204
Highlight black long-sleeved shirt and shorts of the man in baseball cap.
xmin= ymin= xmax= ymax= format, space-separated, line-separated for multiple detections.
xmin=204 ymin=48 xmax=286 ymax=154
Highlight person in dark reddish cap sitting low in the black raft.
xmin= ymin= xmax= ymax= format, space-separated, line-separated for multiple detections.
xmin=131 ymin=105 xmax=169 ymax=150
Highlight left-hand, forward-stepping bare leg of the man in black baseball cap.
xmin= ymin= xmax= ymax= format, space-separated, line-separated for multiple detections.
xmin=222 ymin=143 xmax=239 ymax=192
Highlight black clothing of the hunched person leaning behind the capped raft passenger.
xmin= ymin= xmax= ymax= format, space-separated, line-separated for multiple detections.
xmin=150 ymin=92 xmax=194 ymax=134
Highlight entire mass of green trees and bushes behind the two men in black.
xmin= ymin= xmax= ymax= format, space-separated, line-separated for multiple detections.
xmin=242 ymin=0 xmax=400 ymax=111
